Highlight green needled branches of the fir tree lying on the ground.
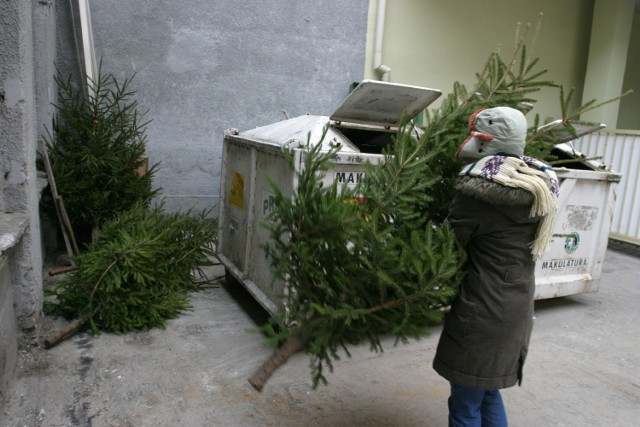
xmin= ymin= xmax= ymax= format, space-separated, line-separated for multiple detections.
xmin=45 ymin=203 xmax=216 ymax=334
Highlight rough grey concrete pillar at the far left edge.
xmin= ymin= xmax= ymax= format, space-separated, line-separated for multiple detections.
xmin=0 ymin=0 xmax=51 ymax=330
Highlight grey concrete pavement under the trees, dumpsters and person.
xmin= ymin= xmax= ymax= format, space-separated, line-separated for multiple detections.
xmin=0 ymin=243 xmax=640 ymax=427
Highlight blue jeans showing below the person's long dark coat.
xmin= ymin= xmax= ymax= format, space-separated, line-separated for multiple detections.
xmin=449 ymin=383 xmax=508 ymax=427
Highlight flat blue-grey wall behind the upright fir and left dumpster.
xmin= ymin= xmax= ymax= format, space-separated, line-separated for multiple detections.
xmin=82 ymin=0 xmax=368 ymax=214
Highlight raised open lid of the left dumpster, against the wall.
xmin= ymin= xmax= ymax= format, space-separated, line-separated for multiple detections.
xmin=330 ymin=80 xmax=442 ymax=127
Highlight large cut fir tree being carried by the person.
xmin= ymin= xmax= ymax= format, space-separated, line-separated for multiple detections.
xmin=249 ymin=21 xmax=632 ymax=391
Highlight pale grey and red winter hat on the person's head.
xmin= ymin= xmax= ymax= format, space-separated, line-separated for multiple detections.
xmin=456 ymin=107 xmax=527 ymax=161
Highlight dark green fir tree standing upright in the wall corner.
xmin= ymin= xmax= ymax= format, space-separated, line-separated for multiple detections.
xmin=43 ymin=61 xmax=158 ymax=242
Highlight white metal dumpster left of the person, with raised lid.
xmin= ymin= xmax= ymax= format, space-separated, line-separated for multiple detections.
xmin=217 ymin=80 xmax=441 ymax=314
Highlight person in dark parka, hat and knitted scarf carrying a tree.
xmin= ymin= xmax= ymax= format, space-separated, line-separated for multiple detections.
xmin=433 ymin=107 xmax=558 ymax=427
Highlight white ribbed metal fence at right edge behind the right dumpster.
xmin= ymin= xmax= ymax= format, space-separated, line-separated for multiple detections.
xmin=573 ymin=130 xmax=640 ymax=245
